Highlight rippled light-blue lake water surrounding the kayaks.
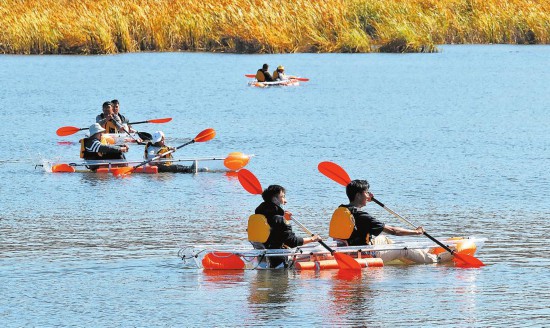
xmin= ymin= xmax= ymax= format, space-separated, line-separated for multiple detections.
xmin=0 ymin=46 xmax=550 ymax=327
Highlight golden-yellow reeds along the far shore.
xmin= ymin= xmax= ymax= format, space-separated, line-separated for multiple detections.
xmin=0 ymin=0 xmax=550 ymax=54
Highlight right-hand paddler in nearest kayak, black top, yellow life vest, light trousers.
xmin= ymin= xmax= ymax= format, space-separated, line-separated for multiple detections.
xmin=329 ymin=180 xmax=444 ymax=263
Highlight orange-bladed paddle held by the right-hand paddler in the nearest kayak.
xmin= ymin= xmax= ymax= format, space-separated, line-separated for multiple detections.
xmin=317 ymin=162 xmax=485 ymax=268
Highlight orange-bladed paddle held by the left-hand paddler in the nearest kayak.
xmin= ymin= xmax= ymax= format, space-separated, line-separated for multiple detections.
xmin=238 ymin=169 xmax=361 ymax=270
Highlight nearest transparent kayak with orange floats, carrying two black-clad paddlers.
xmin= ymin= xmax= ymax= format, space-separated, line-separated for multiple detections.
xmin=178 ymin=237 xmax=487 ymax=270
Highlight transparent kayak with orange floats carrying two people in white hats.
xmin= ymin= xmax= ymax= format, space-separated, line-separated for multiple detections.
xmin=41 ymin=152 xmax=254 ymax=174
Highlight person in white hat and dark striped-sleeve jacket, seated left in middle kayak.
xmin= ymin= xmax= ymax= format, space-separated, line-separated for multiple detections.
xmin=80 ymin=123 xmax=128 ymax=171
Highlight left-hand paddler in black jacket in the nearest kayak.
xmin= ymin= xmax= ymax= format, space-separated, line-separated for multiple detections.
xmin=255 ymin=185 xmax=321 ymax=268
